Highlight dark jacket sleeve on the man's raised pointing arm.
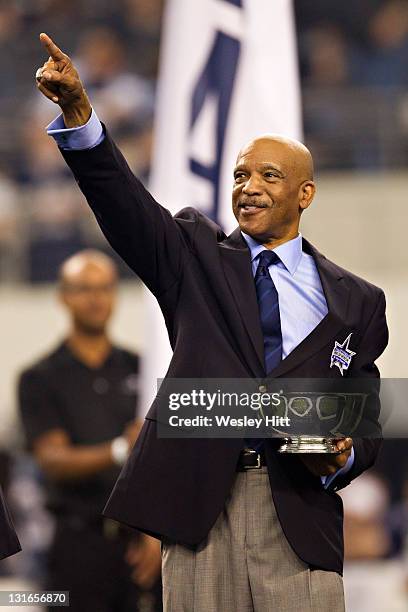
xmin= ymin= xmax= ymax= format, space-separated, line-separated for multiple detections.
xmin=60 ymin=124 xmax=188 ymax=297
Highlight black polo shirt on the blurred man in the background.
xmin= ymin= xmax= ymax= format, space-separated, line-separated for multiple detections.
xmin=18 ymin=342 xmax=139 ymax=518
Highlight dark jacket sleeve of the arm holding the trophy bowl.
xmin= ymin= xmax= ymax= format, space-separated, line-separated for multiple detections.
xmin=327 ymin=290 xmax=388 ymax=491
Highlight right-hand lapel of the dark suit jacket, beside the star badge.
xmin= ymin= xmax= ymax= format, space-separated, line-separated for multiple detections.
xmin=270 ymin=239 xmax=350 ymax=377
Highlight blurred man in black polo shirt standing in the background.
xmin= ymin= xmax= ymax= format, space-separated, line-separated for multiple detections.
xmin=19 ymin=250 xmax=161 ymax=612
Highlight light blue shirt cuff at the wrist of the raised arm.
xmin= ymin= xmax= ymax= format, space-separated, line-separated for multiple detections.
xmin=46 ymin=109 xmax=105 ymax=150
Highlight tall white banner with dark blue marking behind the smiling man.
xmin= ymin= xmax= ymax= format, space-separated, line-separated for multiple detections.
xmin=140 ymin=0 xmax=301 ymax=416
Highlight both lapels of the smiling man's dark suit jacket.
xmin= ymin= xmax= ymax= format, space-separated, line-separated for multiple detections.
xmin=220 ymin=228 xmax=350 ymax=377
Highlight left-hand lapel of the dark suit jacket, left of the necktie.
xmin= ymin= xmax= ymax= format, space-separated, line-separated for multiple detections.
xmin=220 ymin=227 xmax=264 ymax=376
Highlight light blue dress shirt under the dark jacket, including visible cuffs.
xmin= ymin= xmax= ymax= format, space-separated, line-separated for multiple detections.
xmin=47 ymin=109 xmax=354 ymax=488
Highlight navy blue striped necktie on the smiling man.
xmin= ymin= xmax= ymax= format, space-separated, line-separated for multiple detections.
xmin=245 ymin=249 xmax=282 ymax=451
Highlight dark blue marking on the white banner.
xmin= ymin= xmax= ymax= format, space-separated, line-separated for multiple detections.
xmin=190 ymin=32 xmax=240 ymax=221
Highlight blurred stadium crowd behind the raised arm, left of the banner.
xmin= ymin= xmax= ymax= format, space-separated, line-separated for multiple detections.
xmin=0 ymin=0 xmax=162 ymax=282
